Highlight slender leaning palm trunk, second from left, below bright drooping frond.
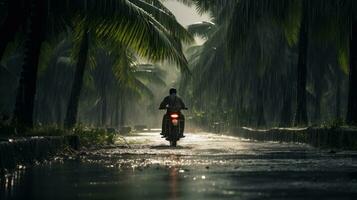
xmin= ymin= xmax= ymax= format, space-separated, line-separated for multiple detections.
xmin=64 ymin=29 xmax=89 ymax=129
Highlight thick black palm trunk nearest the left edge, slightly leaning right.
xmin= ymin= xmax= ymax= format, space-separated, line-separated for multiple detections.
xmin=13 ymin=0 xmax=47 ymax=128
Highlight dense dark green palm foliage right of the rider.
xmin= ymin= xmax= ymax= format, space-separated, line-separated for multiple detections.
xmin=181 ymin=0 xmax=357 ymax=130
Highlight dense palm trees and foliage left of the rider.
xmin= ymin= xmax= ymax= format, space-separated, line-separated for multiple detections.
xmin=0 ymin=0 xmax=193 ymax=131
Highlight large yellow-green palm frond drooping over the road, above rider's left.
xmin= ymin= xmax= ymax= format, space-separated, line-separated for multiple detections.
xmin=71 ymin=0 xmax=192 ymax=71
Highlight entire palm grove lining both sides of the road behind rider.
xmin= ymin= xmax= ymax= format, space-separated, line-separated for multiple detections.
xmin=0 ymin=0 xmax=357 ymax=130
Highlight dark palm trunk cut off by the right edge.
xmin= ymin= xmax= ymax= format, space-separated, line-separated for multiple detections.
xmin=346 ymin=20 xmax=357 ymax=125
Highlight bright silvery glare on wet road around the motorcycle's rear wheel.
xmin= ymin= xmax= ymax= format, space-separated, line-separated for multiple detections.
xmin=85 ymin=133 xmax=320 ymax=170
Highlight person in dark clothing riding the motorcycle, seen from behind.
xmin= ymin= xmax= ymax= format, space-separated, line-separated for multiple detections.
xmin=160 ymin=88 xmax=187 ymax=138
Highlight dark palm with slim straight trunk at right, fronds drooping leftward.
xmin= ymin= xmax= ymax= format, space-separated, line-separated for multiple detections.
xmin=228 ymin=0 xmax=309 ymax=125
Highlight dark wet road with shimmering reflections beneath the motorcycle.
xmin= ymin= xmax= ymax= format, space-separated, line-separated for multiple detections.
xmin=0 ymin=133 xmax=357 ymax=200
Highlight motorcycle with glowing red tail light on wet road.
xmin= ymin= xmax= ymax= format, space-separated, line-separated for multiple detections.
xmin=162 ymin=108 xmax=187 ymax=147
